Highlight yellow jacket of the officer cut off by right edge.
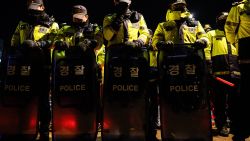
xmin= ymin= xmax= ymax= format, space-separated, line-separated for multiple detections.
xmin=225 ymin=0 xmax=250 ymax=47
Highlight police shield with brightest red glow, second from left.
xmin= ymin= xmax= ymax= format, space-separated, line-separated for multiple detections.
xmin=52 ymin=46 xmax=99 ymax=141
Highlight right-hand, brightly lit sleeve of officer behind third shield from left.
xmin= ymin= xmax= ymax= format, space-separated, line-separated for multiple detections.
xmin=138 ymin=15 xmax=150 ymax=44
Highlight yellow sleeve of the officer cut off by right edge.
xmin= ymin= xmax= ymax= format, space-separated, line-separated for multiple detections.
xmin=225 ymin=6 xmax=240 ymax=44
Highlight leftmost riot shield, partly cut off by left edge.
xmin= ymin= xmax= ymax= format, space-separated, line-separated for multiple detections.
xmin=0 ymin=48 xmax=46 ymax=141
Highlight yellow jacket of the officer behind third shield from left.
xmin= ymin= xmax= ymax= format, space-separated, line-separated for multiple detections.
xmin=103 ymin=11 xmax=150 ymax=47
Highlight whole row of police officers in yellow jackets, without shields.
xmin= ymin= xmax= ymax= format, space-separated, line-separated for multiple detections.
xmin=8 ymin=0 xmax=250 ymax=141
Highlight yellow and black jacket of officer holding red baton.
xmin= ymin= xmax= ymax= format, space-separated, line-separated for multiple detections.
xmin=204 ymin=29 xmax=240 ymax=77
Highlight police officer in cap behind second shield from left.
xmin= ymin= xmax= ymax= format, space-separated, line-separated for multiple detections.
xmin=56 ymin=5 xmax=105 ymax=65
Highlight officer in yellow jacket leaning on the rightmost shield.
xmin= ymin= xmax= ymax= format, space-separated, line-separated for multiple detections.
xmin=152 ymin=0 xmax=208 ymax=48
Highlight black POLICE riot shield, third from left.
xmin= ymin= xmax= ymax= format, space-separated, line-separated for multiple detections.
xmin=102 ymin=45 xmax=148 ymax=141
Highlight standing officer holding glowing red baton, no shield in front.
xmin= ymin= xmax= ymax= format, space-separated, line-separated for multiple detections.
xmin=205 ymin=12 xmax=240 ymax=136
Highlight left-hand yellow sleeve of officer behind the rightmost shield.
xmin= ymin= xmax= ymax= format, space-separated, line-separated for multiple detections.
xmin=152 ymin=23 xmax=164 ymax=49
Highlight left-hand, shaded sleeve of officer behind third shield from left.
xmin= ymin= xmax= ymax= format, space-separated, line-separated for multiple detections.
xmin=103 ymin=16 xmax=116 ymax=41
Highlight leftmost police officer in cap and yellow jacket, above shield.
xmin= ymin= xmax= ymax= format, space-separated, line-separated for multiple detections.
xmin=11 ymin=0 xmax=59 ymax=47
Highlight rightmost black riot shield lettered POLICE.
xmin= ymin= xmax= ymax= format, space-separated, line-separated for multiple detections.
xmin=158 ymin=44 xmax=212 ymax=141
